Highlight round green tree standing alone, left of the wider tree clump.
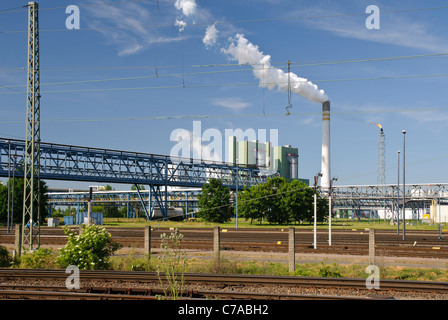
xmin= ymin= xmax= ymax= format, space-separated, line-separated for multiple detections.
xmin=198 ymin=178 xmax=233 ymax=223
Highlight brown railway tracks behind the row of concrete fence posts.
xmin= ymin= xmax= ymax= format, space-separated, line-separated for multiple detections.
xmin=0 ymin=227 xmax=448 ymax=258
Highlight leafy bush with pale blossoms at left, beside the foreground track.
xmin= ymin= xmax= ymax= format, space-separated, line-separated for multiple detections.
xmin=57 ymin=224 xmax=121 ymax=270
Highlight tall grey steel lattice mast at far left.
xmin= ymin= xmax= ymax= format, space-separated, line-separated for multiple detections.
xmin=21 ymin=1 xmax=40 ymax=250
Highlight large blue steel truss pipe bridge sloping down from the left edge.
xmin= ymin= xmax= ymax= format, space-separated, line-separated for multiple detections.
xmin=0 ymin=138 xmax=276 ymax=219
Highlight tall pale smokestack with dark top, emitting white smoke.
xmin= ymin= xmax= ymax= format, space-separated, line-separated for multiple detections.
xmin=320 ymin=101 xmax=331 ymax=190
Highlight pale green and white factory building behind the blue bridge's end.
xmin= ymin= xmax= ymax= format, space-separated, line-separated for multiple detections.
xmin=227 ymin=136 xmax=309 ymax=184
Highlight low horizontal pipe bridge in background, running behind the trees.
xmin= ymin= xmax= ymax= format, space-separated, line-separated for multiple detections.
xmin=47 ymin=184 xmax=448 ymax=218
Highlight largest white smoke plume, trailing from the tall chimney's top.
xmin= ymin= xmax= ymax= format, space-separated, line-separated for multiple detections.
xmin=221 ymin=34 xmax=328 ymax=103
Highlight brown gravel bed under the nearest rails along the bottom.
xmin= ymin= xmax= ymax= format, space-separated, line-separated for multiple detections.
xmin=0 ymin=269 xmax=448 ymax=300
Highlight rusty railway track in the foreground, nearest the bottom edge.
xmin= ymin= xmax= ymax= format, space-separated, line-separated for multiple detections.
xmin=0 ymin=269 xmax=448 ymax=300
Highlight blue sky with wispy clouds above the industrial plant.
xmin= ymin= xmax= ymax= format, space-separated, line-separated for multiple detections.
xmin=0 ymin=0 xmax=448 ymax=189
